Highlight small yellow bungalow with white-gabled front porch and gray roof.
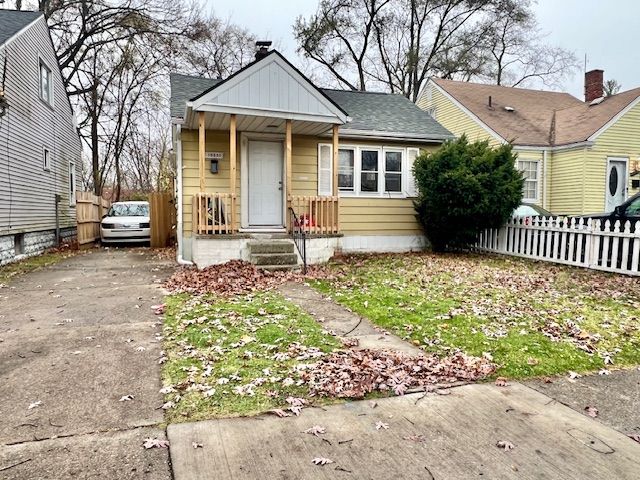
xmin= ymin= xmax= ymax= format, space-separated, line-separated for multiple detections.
xmin=171 ymin=46 xmax=452 ymax=267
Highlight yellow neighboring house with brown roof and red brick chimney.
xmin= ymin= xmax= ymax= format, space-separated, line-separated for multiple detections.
xmin=417 ymin=70 xmax=640 ymax=214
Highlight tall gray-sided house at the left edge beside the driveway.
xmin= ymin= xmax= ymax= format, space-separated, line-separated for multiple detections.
xmin=0 ymin=10 xmax=81 ymax=264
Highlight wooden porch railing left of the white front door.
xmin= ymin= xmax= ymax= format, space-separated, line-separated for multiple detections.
xmin=192 ymin=193 xmax=236 ymax=235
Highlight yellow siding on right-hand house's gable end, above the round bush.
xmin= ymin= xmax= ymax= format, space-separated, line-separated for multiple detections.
xmin=417 ymin=85 xmax=501 ymax=147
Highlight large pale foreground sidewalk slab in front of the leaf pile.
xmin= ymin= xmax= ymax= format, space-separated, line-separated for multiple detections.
xmin=168 ymin=383 xmax=640 ymax=480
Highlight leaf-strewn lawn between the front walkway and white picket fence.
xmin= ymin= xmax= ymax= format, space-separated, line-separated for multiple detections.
xmin=314 ymin=254 xmax=640 ymax=378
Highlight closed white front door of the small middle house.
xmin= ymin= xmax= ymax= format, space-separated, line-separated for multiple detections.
xmin=248 ymin=140 xmax=284 ymax=227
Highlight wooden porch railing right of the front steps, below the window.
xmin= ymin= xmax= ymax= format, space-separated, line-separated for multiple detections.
xmin=289 ymin=196 xmax=340 ymax=235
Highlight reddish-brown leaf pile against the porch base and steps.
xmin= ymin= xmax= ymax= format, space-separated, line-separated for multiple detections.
xmin=165 ymin=260 xmax=330 ymax=297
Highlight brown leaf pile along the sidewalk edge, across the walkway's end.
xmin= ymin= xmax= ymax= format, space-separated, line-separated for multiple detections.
xmin=301 ymin=349 xmax=496 ymax=398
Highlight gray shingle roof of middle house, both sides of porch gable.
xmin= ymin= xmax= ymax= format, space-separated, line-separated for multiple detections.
xmin=171 ymin=73 xmax=453 ymax=139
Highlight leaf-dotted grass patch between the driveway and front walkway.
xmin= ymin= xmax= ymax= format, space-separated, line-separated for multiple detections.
xmin=162 ymin=292 xmax=339 ymax=423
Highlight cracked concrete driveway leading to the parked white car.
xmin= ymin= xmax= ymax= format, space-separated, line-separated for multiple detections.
xmin=0 ymin=249 xmax=173 ymax=480
